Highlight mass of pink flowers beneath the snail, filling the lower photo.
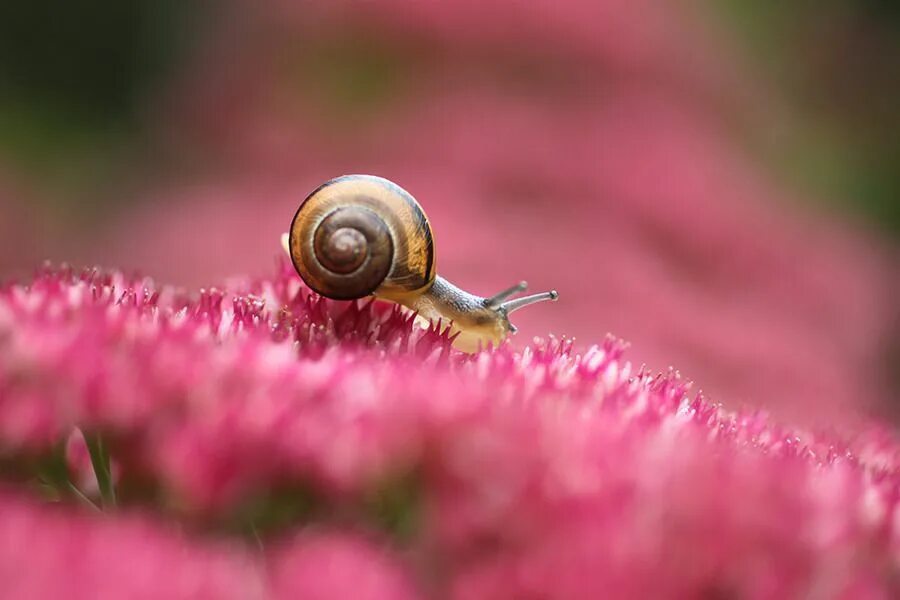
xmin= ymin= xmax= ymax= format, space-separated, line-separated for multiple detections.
xmin=0 ymin=263 xmax=900 ymax=599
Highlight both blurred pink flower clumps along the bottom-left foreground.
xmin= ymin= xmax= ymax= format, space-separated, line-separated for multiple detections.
xmin=0 ymin=495 xmax=415 ymax=600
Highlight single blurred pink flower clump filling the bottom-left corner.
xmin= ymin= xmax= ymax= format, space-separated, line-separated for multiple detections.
xmin=0 ymin=494 xmax=266 ymax=600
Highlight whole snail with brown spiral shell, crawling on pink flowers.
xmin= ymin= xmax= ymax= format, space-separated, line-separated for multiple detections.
xmin=286 ymin=175 xmax=558 ymax=352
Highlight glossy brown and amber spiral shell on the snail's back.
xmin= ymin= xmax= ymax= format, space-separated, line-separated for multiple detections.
xmin=290 ymin=175 xmax=435 ymax=300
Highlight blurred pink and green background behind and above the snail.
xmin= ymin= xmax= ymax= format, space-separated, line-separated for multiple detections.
xmin=0 ymin=0 xmax=900 ymax=426
